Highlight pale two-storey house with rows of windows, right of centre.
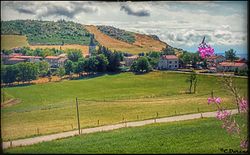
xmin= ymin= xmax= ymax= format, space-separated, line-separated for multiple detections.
xmin=158 ymin=55 xmax=179 ymax=70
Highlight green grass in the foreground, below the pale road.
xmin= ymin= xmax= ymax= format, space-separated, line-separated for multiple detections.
xmin=4 ymin=114 xmax=246 ymax=154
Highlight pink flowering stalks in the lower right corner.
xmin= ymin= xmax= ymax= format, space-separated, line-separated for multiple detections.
xmin=207 ymin=76 xmax=248 ymax=149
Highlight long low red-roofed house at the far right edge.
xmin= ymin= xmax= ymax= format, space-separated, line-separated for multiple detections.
xmin=217 ymin=62 xmax=248 ymax=72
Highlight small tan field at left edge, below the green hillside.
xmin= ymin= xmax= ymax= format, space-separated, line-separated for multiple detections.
xmin=1 ymin=35 xmax=29 ymax=50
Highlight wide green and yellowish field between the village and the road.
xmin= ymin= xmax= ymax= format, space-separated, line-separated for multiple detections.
xmin=1 ymin=71 xmax=247 ymax=141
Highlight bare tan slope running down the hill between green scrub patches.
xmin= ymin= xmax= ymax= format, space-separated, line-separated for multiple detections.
xmin=85 ymin=25 xmax=166 ymax=54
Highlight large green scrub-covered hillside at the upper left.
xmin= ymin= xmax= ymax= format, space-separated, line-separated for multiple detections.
xmin=1 ymin=20 xmax=89 ymax=45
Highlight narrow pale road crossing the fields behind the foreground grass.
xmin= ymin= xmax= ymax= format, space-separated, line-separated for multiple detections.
xmin=3 ymin=109 xmax=238 ymax=149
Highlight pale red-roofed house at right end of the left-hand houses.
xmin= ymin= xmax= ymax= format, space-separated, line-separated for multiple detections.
xmin=45 ymin=56 xmax=67 ymax=68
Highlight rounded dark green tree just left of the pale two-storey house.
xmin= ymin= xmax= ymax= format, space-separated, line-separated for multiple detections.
xmin=131 ymin=57 xmax=152 ymax=73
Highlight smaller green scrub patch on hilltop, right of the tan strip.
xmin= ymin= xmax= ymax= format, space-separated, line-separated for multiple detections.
xmin=97 ymin=26 xmax=135 ymax=43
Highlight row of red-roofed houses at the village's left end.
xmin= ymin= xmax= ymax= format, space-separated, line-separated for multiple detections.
xmin=1 ymin=53 xmax=68 ymax=68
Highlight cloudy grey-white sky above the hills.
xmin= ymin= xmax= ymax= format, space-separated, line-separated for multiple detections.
xmin=1 ymin=1 xmax=247 ymax=53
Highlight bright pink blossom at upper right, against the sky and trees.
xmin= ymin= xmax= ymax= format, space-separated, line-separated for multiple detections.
xmin=198 ymin=37 xmax=214 ymax=59
